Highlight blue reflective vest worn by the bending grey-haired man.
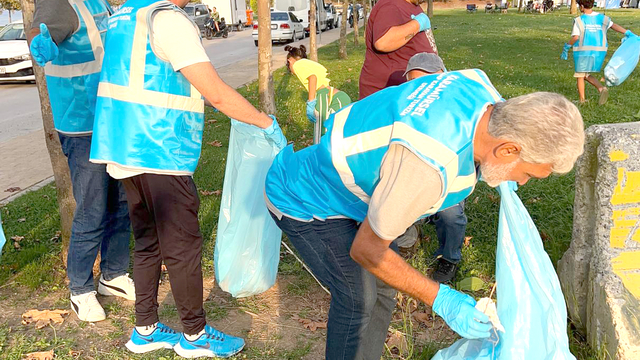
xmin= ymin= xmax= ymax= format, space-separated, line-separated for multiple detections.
xmin=265 ymin=69 xmax=502 ymax=221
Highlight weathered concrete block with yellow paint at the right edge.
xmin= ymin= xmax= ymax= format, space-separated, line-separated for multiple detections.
xmin=558 ymin=123 xmax=640 ymax=360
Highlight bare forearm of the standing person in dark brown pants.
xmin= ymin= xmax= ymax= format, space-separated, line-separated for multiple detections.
xmin=180 ymin=62 xmax=273 ymax=129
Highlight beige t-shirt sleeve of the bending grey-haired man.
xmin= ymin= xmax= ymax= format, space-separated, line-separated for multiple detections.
xmin=367 ymin=144 xmax=442 ymax=241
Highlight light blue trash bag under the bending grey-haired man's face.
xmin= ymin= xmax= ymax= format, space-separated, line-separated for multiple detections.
xmin=433 ymin=182 xmax=575 ymax=360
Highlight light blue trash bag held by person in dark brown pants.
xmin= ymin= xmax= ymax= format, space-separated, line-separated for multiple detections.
xmin=214 ymin=119 xmax=282 ymax=297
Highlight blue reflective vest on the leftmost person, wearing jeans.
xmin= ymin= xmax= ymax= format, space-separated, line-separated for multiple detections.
xmin=44 ymin=0 xmax=111 ymax=135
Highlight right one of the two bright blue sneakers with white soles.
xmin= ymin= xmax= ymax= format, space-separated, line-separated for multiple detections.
xmin=173 ymin=325 xmax=244 ymax=359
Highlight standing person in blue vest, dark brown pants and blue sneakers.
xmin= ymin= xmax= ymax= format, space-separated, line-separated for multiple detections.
xmin=91 ymin=0 xmax=286 ymax=358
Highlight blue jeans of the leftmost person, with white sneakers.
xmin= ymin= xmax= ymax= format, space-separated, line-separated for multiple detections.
xmin=58 ymin=134 xmax=131 ymax=295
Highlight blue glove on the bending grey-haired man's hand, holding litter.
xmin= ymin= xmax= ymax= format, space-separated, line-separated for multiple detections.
xmin=433 ymin=284 xmax=492 ymax=339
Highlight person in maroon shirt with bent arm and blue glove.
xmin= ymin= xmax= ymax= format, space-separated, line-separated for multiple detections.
xmin=360 ymin=0 xmax=438 ymax=99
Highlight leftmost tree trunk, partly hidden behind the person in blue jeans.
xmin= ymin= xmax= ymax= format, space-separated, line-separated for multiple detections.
xmin=21 ymin=0 xmax=76 ymax=266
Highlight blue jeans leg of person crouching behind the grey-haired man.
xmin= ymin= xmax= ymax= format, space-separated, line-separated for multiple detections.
xmin=433 ymin=201 xmax=467 ymax=264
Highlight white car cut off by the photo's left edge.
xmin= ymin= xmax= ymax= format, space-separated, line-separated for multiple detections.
xmin=0 ymin=22 xmax=36 ymax=82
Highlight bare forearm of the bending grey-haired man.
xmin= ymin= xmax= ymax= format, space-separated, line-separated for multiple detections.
xmin=350 ymin=219 xmax=440 ymax=305
